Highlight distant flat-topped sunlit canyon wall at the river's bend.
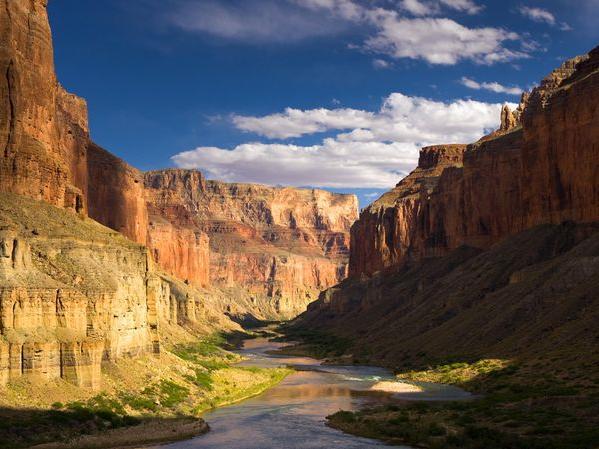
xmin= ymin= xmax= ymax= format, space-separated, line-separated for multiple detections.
xmin=145 ymin=170 xmax=357 ymax=318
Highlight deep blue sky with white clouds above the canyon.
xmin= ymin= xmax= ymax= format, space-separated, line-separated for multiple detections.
xmin=49 ymin=0 xmax=599 ymax=207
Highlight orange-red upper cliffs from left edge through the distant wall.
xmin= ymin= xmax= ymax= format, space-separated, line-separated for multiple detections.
xmin=0 ymin=0 xmax=357 ymax=318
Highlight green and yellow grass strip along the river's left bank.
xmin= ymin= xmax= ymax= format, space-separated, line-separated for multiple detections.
xmin=0 ymin=334 xmax=292 ymax=448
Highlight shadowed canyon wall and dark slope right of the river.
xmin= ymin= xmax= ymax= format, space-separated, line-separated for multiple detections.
xmin=298 ymin=47 xmax=599 ymax=366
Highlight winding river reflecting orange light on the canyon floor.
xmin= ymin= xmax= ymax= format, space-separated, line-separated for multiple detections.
xmin=149 ymin=338 xmax=469 ymax=449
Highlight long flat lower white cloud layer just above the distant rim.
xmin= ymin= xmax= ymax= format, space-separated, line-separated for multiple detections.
xmin=173 ymin=139 xmax=418 ymax=188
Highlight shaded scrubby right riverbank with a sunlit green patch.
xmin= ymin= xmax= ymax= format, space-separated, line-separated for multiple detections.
xmin=328 ymin=358 xmax=599 ymax=449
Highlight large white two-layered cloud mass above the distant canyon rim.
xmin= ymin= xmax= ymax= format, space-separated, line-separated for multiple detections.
xmin=172 ymin=93 xmax=502 ymax=188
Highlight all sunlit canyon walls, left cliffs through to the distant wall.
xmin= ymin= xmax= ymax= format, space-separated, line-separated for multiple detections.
xmin=0 ymin=0 xmax=357 ymax=389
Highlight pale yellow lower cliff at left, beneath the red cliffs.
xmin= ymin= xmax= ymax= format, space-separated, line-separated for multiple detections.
xmin=0 ymin=193 xmax=226 ymax=388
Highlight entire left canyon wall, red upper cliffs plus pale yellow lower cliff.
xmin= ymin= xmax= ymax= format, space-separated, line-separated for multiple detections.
xmin=0 ymin=0 xmax=234 ymax=388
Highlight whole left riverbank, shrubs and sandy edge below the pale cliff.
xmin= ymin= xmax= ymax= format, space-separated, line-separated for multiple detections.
xmin=0 ymin=334 xmax=292 ymax=449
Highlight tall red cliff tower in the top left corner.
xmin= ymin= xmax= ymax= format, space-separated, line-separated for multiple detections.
xmin=0 ymin=0 xmax=87 ymax=211
